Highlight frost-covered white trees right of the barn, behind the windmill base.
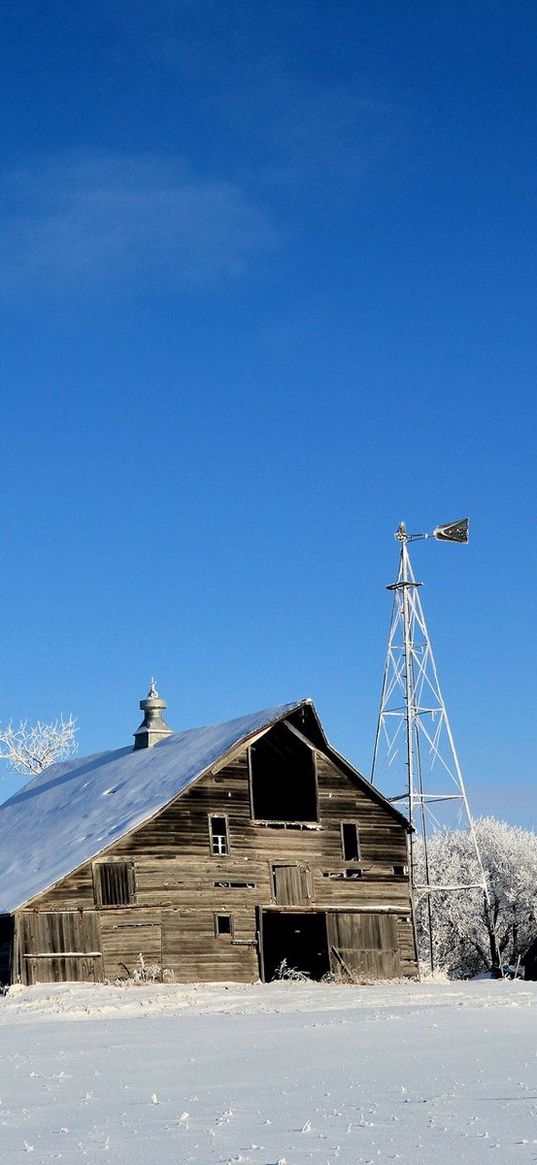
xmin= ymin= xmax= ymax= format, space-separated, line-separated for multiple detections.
xmin=415 ymin=817 xmax=537 ymax=979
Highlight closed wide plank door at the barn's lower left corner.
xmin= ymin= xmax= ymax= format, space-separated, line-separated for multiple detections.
xmin=20 ymin=910 xmax=103 ymax=983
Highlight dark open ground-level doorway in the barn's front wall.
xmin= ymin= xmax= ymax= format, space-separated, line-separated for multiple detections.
xmin=261 ymin=910 xmax=330 ymax=983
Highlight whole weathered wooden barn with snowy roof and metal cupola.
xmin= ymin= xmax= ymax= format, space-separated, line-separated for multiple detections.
xmin=0 ymin=685 xmax=417 ymax=983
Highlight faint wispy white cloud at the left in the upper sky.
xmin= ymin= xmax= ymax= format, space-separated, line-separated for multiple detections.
xmin=0 ymin=153 xmax=276 ymax=294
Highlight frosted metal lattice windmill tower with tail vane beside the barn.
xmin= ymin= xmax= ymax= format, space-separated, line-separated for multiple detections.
xmin=372 ymin=518 xmax=490 ymax=970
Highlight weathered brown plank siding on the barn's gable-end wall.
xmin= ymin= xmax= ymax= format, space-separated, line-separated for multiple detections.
xmin=11 ymin=748 xmax=416 ymax=982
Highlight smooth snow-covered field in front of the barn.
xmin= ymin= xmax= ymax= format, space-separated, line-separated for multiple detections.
xmin=0 ymin=982 xmax=537 ymax=1165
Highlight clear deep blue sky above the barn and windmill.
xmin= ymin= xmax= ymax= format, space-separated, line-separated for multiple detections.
xmin=0 ymin=0 xmax=537 ymax=826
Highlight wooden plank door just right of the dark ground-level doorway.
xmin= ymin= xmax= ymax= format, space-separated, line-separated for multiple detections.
xmin=327 ymin=910 xmax=401 ymax=979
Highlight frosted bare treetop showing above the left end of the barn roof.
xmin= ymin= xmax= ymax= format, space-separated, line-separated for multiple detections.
xmin=0 ymin=715 xmax=77 ymax=777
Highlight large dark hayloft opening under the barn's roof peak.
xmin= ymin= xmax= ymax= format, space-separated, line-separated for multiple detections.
xmin=249 ymin=723 xmax=318 ymax=821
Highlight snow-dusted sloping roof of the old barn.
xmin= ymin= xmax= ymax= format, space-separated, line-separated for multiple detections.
xmin=0 ymin=700 xmax=408 ymax=915
